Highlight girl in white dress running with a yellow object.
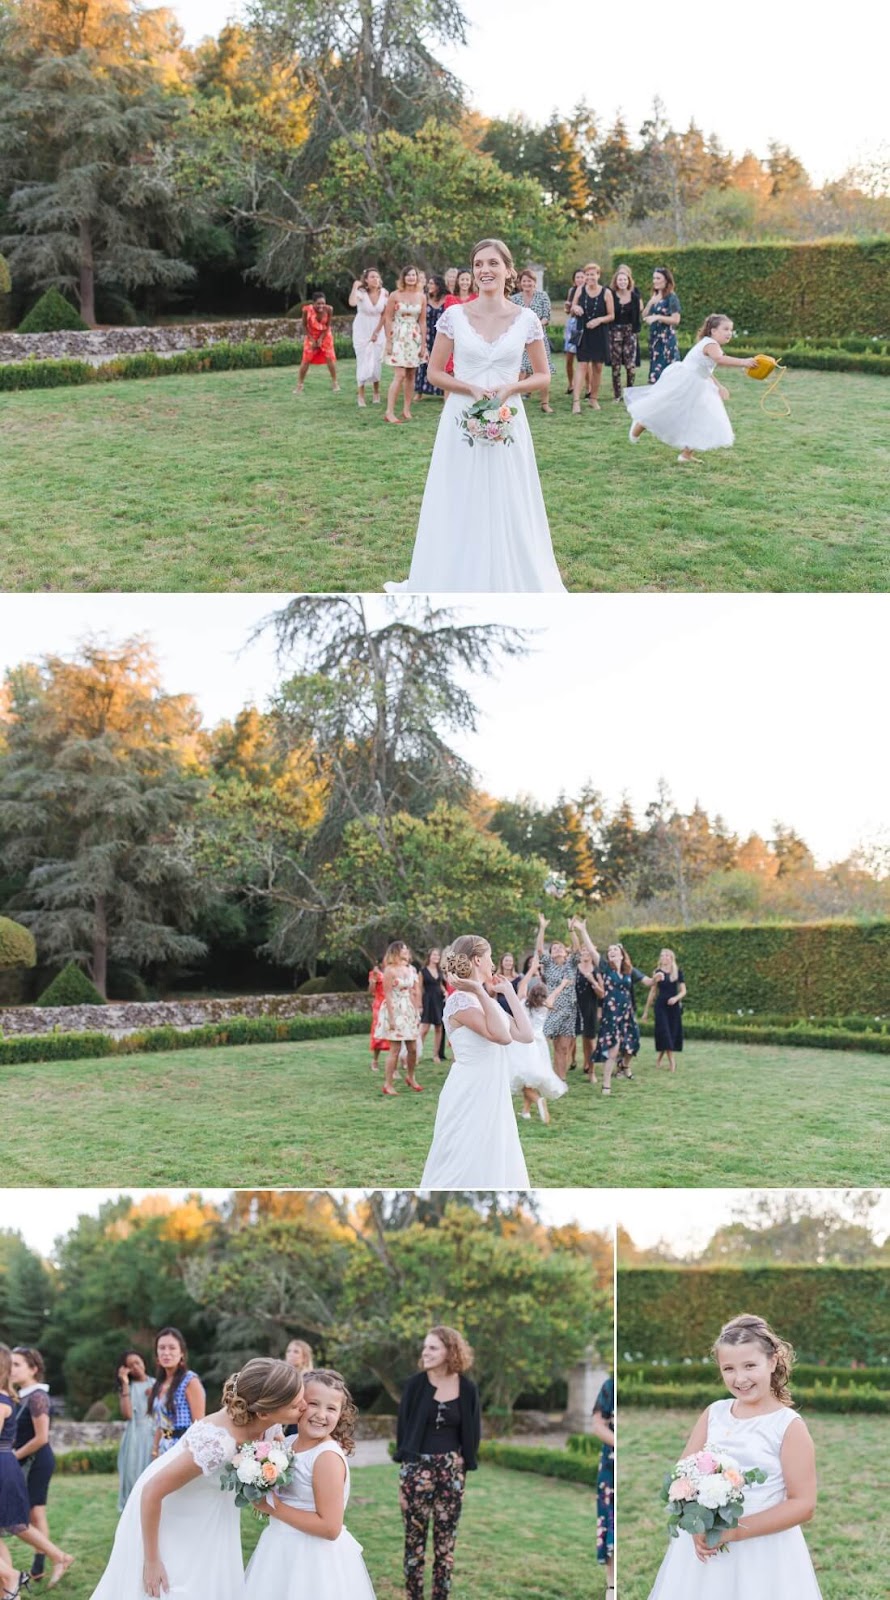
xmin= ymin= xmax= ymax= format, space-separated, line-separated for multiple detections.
xmin=624 ymin=312 xmax=756 ymax=464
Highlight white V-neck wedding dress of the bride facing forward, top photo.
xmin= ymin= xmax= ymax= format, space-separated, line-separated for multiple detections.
xmin=384 ymin=306 xmax=565 ymax=594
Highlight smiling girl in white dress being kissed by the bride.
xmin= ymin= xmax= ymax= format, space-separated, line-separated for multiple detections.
xmin=245 ymin=1368 xmax=375 ymax=1600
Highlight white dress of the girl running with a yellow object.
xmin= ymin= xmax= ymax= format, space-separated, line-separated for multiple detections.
xmin=624 ymin=339 xmax=735 ymax=450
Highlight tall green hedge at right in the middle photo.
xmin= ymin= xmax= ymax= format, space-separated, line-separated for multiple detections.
xmin=618 ymin=922 xmax=890 ymax=1018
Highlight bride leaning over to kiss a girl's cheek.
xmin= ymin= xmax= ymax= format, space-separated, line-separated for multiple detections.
xmin=93 ymin=1357 xmax=306 ymax=1600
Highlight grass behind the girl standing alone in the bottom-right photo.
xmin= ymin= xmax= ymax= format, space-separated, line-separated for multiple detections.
xmin=616 ymin=1408 xmax=890 ymax=1600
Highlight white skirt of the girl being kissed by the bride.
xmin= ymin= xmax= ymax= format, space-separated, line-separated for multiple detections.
xmin=244 ymin=1522 xmax=375 ymax=1600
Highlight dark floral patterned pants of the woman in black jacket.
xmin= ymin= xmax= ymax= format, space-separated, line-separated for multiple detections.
xmin=400 ymin=1451 xmax=466 ymax=1600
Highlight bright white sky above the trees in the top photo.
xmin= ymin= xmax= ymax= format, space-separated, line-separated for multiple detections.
xmin=173 ymin=0 xmax=890 ymax=182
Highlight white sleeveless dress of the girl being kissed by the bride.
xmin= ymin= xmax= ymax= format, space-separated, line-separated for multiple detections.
xmin=241 ymin=1438 xmax=375 ymax=1600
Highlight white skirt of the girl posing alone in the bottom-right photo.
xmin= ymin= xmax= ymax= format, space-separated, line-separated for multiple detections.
xmin=648 ymin=1528 xmax=821 ymax=1600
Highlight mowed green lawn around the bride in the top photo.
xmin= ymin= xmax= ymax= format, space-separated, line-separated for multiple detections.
xmin=0 ymin=360 xmax=890 ymax=592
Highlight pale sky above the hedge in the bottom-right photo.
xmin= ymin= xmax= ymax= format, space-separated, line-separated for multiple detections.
xmin=616 ymin=1189 xmax=890 ymax=1254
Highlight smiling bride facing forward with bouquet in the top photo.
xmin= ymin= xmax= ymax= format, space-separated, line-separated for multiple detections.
xmin=384 ymin=238 xmax=565 ymax=594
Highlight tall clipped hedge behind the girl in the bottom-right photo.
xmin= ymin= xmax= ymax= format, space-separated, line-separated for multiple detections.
xmin=618 ymin=1260 xmax=890 ymax=1366
